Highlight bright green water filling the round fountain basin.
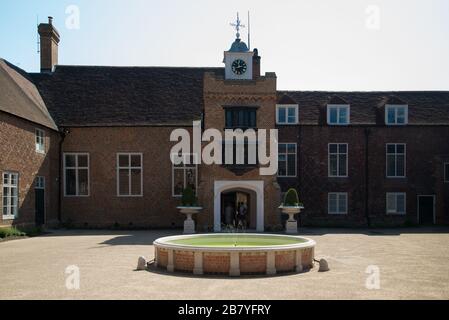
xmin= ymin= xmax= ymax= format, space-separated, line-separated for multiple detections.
xmin=167 ymin=235 xmax=306 ymax=247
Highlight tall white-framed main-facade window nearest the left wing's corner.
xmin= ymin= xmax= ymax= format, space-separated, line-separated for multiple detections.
xmin=64 ymin=153 xmax=90 ymax=197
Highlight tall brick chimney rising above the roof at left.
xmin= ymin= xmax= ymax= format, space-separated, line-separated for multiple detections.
xmin=37 ymin=17 xmax=60 ymax=72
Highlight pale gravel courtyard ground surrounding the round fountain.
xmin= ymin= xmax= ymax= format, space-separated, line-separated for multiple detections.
xmin=0 ymin=228 xmax=449 ymax=300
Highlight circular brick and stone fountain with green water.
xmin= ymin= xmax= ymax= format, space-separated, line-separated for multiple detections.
xmin=153 ymin=233 xmax=315 ymax=276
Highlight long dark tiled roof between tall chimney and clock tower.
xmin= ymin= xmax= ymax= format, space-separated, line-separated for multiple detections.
xmin=31 ymin=66 xmax=224 ymax=126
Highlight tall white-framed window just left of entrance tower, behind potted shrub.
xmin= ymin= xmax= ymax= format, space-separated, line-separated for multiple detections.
xmin=172 ymin=154 xmax=198 ymax=197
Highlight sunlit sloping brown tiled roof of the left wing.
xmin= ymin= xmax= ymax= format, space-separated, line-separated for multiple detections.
xmin=0 ymin=59 xmax=58 ymax=130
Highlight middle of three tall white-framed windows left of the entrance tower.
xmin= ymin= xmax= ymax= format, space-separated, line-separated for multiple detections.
xmin=117 ymin=153 xmax=143 ymax=197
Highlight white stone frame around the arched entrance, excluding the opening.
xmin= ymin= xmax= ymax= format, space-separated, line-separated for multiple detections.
xmin=214 ymin=180 xmax=265 ymax=232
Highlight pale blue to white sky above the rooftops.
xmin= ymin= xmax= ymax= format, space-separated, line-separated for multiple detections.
xmin=0 ymin=0 xmax=449 ymax=91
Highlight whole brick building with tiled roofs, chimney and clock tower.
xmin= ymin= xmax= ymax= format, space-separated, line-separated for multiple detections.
xmin=0 ymin=20 xmax=449 ymax=231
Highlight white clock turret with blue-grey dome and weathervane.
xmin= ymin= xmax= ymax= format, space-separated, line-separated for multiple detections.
xmin=224 ymin=14 xmax=254 ymax=80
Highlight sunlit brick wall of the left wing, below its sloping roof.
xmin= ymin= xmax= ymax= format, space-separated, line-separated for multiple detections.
xmin=0 ymin=111 xmax=59 ymax=227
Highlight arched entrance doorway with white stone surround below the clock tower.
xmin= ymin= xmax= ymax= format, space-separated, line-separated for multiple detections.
xmin=214 ymin=181 xmax=264 ymax=232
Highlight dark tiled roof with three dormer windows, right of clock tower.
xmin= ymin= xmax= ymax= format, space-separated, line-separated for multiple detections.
xmin=278 ymin=91 xmax=449 ymax=125
